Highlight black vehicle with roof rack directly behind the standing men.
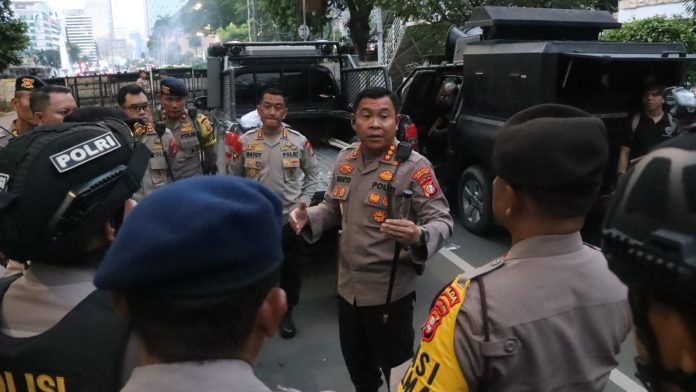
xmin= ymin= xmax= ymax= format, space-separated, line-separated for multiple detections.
xmin=198 ymin=41 xmax=390 ymax=145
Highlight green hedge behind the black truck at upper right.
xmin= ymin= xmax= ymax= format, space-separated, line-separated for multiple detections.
xmin=602 ymin=16 xmax=696 ymax=53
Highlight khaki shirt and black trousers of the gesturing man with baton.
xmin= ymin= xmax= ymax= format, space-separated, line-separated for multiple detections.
xmin=303 ymin=143 xmax=453 ymax=390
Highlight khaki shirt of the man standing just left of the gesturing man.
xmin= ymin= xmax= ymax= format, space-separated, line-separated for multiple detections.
xmin=227 ymin=128 xmax=319 ymax=223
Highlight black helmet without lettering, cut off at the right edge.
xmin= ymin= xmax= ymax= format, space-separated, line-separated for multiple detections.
xmin=602 ymin=134 xmax=696 ymax=305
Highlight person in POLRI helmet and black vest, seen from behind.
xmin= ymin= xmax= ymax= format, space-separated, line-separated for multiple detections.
xmin=0 ymin=120 xmax=149 ymax=391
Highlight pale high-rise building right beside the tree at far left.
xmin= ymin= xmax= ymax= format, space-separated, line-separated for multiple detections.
xmin=11 ymin=0 xmax=63 ymax=53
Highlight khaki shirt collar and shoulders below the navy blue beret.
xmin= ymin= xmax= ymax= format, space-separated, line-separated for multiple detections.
xmin=121 ymin=359 xmax=271 ymax=392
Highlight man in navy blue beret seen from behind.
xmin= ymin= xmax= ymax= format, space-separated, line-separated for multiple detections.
xmin=95 ymin=176 xmax=287 ymax=392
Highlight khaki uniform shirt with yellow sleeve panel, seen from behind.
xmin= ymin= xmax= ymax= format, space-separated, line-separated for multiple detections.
xmin=399 ymin=232 xmax=631 ymax=392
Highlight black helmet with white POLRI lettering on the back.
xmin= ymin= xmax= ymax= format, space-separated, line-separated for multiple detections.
xmin=0 ymin=120 xmax=150 ymax=260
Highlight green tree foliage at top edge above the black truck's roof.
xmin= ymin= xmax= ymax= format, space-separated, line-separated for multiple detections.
xmin=377 ymin=0 xmax=617 ymax=26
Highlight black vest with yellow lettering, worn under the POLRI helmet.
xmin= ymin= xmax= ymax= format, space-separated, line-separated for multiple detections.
xmin=0 ymin=277 xmax=129 ymax=392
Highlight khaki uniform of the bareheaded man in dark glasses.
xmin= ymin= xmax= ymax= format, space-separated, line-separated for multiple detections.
xmin=133 ymin=123 xmax=177 ymax=201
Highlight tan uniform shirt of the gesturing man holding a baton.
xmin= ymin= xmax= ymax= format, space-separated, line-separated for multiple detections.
xmin=304 ymin=143 xmax=452 ymax=306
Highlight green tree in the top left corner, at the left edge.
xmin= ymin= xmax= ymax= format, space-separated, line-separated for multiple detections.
xmin=0 ymin=0 xmax=30 ymax=72
